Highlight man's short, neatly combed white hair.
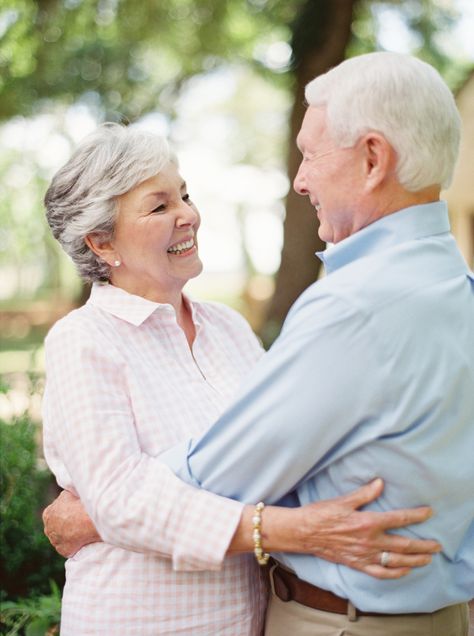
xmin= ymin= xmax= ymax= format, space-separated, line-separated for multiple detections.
xmin=305 ymin=52 xmax=461 ymax=192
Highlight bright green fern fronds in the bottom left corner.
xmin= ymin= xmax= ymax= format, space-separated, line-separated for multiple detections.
xmin=0 ymin=581 xmax=61 ymax=636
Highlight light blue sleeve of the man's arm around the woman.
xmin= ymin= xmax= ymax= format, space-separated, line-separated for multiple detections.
xmin=160 ymin=290 xmax=387 ymax=503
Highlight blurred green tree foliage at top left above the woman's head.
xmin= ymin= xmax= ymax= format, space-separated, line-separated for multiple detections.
xmin=0 ymin=0 xmax=303 ymax=119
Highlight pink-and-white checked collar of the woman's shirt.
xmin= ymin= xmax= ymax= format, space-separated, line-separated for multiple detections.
xmin=87 ymin=283 xmax=195 ymax=327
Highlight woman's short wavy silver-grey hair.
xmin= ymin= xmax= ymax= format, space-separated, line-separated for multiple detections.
xmin=44 ymin=123 xmax=176 ymax=281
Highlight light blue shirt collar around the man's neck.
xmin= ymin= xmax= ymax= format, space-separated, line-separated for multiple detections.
xmin=316 ymin=201 xmax=450 ymax=274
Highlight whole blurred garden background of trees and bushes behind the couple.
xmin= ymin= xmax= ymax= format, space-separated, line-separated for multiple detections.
xmin=0 ymin=0 xmax=474 ymax=636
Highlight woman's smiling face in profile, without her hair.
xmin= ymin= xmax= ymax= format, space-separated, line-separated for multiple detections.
xmin=107 ymin=162 xmax=202 ymax=302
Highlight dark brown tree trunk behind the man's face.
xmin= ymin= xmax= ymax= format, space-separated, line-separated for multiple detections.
xmin=261 ymin=0 xmax=358 ymax=345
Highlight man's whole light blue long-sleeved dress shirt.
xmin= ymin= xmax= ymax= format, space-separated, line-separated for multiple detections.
xmin=162 ymin=202 xmax=474 ymax=613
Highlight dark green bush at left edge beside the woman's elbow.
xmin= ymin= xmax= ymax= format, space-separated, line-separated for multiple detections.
xmin=0 ymin=396 xmax=64 ymax=598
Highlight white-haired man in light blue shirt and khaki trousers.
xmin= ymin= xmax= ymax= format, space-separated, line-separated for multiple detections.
xmin=43 ymin=53 xmax=474 ymax=636
